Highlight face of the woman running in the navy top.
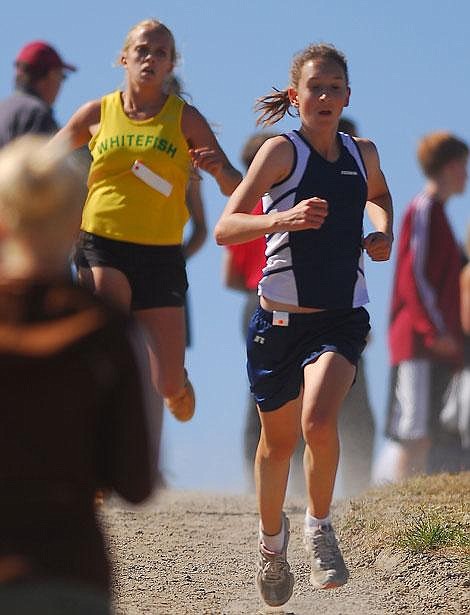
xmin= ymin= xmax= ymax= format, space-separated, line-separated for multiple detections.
xmin=289 ymin=59 xmax=350 ymax=127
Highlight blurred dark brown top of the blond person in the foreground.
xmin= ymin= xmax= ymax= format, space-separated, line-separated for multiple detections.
xmin=0 ymin=283 xmax=156 ymax=591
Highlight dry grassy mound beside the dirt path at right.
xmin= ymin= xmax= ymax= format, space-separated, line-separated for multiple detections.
xmin=339 ymin=472 xmax=470 ymax=570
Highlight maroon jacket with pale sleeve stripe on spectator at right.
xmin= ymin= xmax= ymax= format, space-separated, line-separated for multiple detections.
xmin=389 ymin=192 xmax=462 ymax=365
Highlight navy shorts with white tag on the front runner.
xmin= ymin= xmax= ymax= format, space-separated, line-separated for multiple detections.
xmin=247 ymin=307 xmax=370 ymax=412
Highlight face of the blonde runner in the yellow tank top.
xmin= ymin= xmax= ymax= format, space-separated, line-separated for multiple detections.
xmin=122 ymin=29 xmax=173 ymax=85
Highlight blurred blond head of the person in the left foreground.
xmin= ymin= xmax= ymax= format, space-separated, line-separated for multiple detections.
xmin=0 ymin=135 xmax=86 ymax=279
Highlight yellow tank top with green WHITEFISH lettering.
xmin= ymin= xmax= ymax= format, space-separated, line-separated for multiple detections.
xmin=81 ymin=91 xmax=191 ymax=245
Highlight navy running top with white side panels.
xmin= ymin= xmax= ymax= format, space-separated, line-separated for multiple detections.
xmin=258 ymin=131 xmax=369 ymax=309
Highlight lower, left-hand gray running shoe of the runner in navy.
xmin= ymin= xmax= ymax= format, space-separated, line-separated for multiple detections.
xmin=256 ymin=513 xmax=294 ymax=606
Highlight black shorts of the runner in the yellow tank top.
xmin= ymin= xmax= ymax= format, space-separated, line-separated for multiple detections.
xmin=74 ymin=231 xmax=188 ymax=310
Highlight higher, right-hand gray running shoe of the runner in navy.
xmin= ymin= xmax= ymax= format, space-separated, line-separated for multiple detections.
xmin=304 ymin=525 xmax=349 ymax=589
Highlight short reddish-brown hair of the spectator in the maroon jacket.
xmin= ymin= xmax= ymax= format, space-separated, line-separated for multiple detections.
xmin=417 ymin=131 xmax=469 ymax=179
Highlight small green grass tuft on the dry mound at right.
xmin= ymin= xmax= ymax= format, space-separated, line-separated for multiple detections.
xmin=397 ymin=510 xmax=470 ymax=553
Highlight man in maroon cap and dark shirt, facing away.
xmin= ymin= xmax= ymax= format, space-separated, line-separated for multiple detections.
xmin=0 ymin=41 xmax=77 ymax=147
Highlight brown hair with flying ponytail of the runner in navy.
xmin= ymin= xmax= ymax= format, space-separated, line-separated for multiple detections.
xmin=255 ymin=43 xmax=349 ymax=126
